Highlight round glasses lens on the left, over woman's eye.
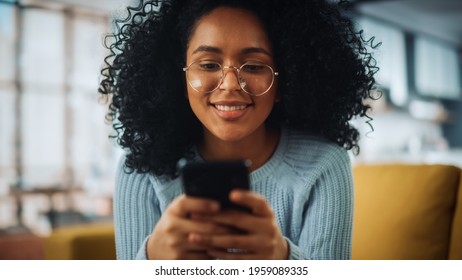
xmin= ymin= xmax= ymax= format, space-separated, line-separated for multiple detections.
xmin=186 ymin=61 xmax=222 ymax=93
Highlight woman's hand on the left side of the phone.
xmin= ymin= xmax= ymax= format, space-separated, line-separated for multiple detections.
xmin=146 ymin=195 xmax=229 ymax=260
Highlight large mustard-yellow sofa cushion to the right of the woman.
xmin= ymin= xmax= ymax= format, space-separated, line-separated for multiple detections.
xmin=353 ymin=164 xmax=460 ymax=259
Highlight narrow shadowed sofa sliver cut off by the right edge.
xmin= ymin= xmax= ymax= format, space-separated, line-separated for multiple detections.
xmin=449 ymin=167 xmax=462 ymax=260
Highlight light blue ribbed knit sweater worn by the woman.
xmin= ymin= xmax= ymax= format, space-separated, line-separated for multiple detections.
xmin=114 ymin=128 xmax=353 ymax=259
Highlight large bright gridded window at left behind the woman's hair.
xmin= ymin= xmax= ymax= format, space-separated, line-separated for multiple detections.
xmin=0 ymin=0 xmax=121 ymax=232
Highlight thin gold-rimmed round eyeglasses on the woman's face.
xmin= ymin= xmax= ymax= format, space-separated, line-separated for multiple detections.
xmin=183 ymin=60 xmax=279 ymax=96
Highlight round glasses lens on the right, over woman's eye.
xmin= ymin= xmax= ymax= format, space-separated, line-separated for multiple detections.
xmin=239 ymin=62 xmax=274 ymax=96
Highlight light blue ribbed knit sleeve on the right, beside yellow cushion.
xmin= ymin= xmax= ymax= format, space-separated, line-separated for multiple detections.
xmin=296 ymin=147 xmax=353 ymax=260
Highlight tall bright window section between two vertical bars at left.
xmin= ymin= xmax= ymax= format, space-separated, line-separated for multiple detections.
xmin=19 ymin=8 xmax=67 ymax=188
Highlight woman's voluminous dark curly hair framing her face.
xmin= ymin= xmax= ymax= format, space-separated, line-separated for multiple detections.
xmin=99 ymin=0 xmax=378 ymax=178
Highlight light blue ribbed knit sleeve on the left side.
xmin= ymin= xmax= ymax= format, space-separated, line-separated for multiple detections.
xmin=114 ymin=158 xmax=160 ymax=260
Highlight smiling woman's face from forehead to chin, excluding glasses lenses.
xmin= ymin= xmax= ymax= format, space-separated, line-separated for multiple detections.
xmin=186 ymin=7 xmax=277 ymax=147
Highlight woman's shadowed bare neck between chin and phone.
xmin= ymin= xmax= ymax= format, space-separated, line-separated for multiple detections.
xmin=199 ymin=127 xmax=279 ymax=171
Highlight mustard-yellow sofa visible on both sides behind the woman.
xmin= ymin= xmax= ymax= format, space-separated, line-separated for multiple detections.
xmin=45 ymin=164 xmax=462 ymax=260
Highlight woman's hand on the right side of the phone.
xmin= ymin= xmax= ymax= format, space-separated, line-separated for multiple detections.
xmin=189 ymin=190 xmax=289 ymax=260
